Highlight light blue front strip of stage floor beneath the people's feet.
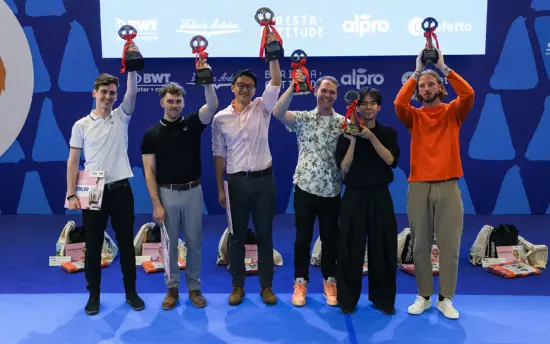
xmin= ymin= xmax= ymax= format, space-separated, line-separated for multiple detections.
xmin=0 ymin=293 xmax=550 ymax=344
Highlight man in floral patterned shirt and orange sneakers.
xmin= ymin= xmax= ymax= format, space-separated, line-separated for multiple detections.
xmin=273 ymin=70 xmax=345 ymax=306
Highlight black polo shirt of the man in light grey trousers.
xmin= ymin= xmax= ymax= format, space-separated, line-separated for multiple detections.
xmin=141 ymin=111 xmax=206 ymax=184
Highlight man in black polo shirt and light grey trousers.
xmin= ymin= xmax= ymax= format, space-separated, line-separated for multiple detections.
xmin=141 ymin=64 xmax=218 ymax=309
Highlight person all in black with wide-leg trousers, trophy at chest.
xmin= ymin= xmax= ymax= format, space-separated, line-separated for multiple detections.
xmin=336 ymin=88 xmax=399 ymax=314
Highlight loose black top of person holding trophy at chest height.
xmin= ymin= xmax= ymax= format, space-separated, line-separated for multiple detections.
xmin=336 ymin=121 xmax=400 ymax=188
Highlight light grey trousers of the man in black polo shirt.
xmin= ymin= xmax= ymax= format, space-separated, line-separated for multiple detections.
xmin=159 ymin=185 xmax=204 ymax=290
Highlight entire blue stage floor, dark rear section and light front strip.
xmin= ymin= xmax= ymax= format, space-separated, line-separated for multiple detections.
xmin=0 ymin=215 xmax=550 ymax=344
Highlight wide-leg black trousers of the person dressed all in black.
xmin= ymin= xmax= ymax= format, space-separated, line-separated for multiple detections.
xmin=337 ymin=187 xmax=397 ymax=308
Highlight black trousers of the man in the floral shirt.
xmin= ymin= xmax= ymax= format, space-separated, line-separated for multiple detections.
xmin=294 ymin=185 xmax=340 ymax=281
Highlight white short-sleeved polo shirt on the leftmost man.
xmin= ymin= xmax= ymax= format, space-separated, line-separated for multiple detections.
xmin=69 ymin=105 xmax=134 ymax=184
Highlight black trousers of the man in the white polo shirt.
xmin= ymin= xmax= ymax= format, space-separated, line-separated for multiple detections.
xmin=82 ymin=180 xmax=136 ymax=295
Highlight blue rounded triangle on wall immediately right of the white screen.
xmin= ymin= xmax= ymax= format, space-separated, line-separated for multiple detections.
xmin=491 ymin=16 xmax=539 ymax=90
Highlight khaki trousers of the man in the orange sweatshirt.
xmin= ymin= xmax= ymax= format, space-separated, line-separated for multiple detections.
xmin=407 ymin=180 xmax=464 ymax=298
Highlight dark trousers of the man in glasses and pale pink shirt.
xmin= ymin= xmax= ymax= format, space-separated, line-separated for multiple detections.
xmin=227 ymin=169 xmax=276 ymax=288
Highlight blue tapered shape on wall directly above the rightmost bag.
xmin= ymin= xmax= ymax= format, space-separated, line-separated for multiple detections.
xmin=493 ymin=166 xmax=531 ymax=214
